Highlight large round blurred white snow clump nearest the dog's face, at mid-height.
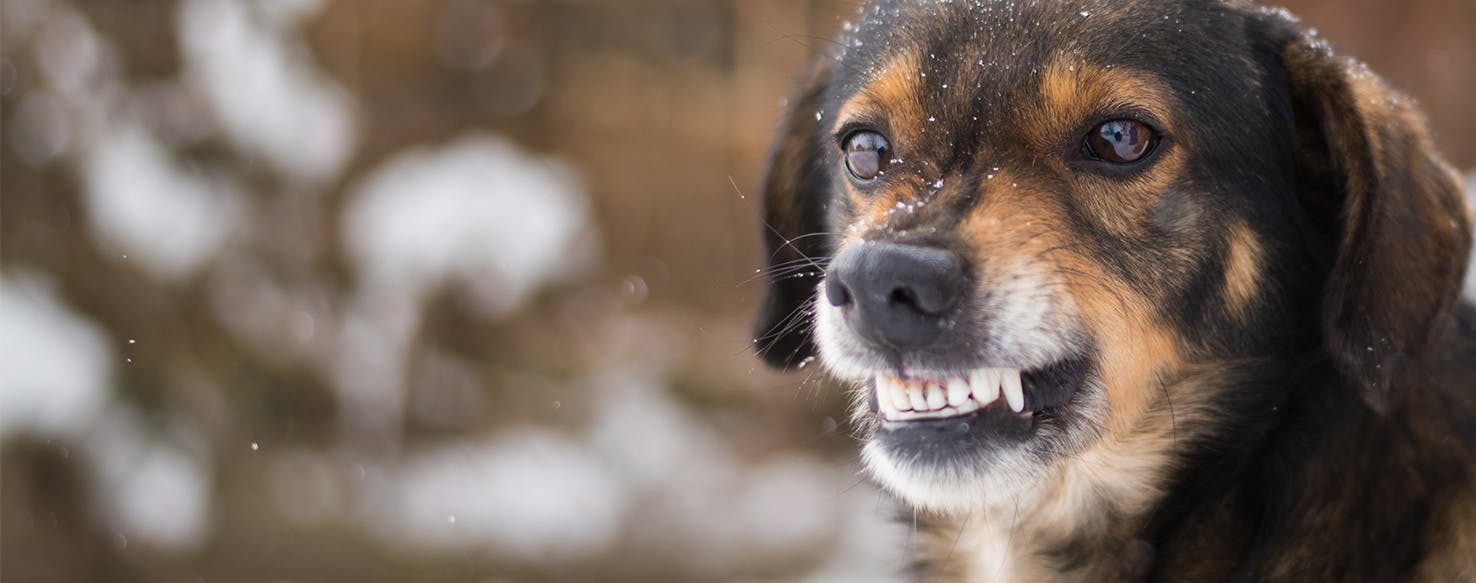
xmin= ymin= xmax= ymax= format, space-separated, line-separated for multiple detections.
xmin=344 ymin=136 xmax=593 ymax=316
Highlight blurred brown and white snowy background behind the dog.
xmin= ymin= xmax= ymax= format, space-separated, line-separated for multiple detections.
xmin=0 ymin=0 xmax=1476 ymax=583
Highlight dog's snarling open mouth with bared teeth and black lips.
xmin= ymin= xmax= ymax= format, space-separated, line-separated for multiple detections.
xmin=869 ymin=357 xmax=1089 ymax=434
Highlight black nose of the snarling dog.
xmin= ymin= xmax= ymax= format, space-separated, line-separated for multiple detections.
xmin=825 ymin=244 xmax=968 ymax=350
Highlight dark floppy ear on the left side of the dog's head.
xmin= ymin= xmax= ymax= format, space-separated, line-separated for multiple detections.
xmin=753 ymin=58 xmax=832 ymax=369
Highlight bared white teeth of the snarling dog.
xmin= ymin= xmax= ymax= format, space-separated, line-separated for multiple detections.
xmin=877 ymin=369 xmax=1024 ymax=421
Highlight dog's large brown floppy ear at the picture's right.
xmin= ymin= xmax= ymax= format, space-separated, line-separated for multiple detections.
xmin=1261 ymin=12 xmax=1472 ymax=412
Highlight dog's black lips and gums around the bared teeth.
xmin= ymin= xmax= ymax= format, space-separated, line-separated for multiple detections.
xmin=868 ymin=354 xmax=1091 ymax=430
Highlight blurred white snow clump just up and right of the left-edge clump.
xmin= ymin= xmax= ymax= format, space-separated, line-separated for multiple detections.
xmin=83 ymin=125 xmax=242 ymax=279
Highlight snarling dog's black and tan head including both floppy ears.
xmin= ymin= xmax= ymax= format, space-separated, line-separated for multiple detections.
xmin=756 ymin=0 xmax=1470 ymax=509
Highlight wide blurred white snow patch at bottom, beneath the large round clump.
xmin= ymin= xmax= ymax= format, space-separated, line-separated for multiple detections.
xmin=366 ymin=430 xmax=629 ymax=562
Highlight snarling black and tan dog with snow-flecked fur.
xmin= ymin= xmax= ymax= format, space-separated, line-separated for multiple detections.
xmin=754 ymin=0 xmax=1476 ymax=582
